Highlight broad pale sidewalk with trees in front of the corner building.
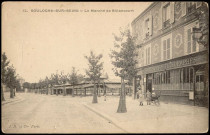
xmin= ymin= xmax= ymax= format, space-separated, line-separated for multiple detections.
xmin=84 ymin=96 xmax=208 ymax=133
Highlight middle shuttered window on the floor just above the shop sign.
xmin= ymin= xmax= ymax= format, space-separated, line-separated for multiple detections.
xmin=163 ymin=38 xmax=170 ymax=60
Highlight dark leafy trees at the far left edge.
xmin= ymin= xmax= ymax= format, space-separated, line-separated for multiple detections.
xmin=1 ymin=52 xmax=21 ymax=101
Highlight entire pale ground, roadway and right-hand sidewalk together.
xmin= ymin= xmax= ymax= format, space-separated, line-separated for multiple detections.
xmin=2 ymin=93 xmax=208 ymax=133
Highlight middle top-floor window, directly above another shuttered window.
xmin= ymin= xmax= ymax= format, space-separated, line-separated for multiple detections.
xmin=163 ymin=3 xmax=170 ymax=27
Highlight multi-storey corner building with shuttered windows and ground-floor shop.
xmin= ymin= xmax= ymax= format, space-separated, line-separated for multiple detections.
xmin=132 ymin=2 xmax=208 ymax=104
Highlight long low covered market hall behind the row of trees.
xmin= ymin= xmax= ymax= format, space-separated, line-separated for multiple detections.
xmin=51 ymin=80 xmax=131 ymax=96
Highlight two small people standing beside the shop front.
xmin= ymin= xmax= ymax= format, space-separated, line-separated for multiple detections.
xmin=137 ymin=89 xmax=155 ymax=106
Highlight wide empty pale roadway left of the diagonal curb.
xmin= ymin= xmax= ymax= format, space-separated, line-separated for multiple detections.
xmin=2 ymin=94 xmax=123 ymax=133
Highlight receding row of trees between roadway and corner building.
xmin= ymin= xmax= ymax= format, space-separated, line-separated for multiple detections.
xmin=24 ymin=28 xmax=138 ymax=113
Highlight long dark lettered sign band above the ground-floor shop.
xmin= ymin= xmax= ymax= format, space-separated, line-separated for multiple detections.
xmin=141 ymin=52 xmax=207 ymax=74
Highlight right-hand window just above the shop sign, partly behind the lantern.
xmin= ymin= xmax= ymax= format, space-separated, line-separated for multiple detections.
xmin=187 ymin=28 xmax=196 ymax=54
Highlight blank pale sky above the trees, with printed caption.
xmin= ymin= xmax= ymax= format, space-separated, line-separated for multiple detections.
xmin=2 ymin=2 xmax=151 ymax=83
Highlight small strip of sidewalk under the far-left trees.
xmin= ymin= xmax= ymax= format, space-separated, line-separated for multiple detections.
xmin=1 ymin=92 xmax=24 ymax=105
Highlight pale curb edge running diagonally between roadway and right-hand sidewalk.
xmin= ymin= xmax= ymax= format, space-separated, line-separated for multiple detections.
xmin=83 ymin=104 xmax=129 ymax=133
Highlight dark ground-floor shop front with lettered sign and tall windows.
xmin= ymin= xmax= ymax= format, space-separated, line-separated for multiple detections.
xmin=135 ymin=52 xmax=208 ymax=106
